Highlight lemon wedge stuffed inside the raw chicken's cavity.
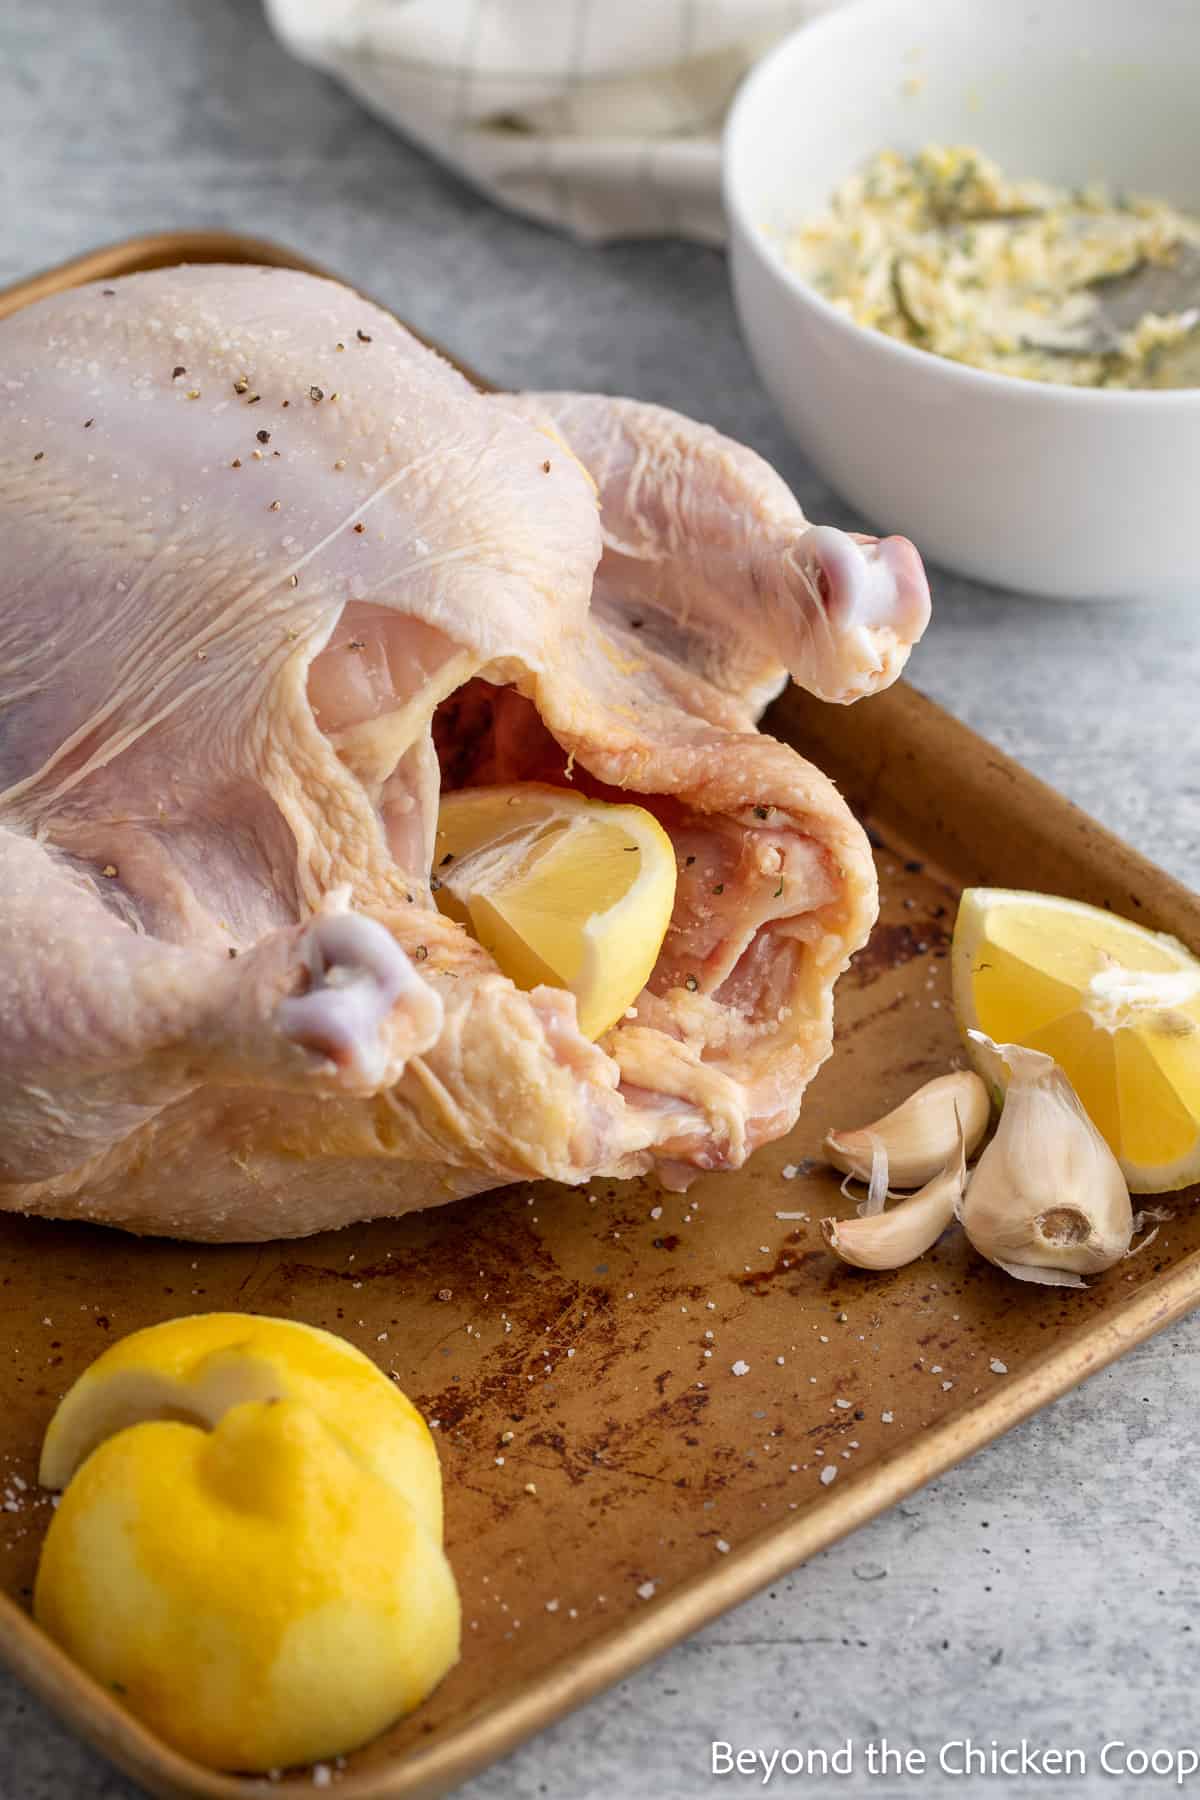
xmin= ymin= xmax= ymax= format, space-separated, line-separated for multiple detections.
xmin=434 ymin=781 xmax=675 ymax=1039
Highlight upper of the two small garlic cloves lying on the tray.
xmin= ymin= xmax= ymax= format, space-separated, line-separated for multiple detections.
xmin=824 ymin=1069 xmax=991 ymax=1188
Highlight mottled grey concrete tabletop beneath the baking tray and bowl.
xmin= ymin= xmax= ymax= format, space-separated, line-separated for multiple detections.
xmin=0 ymin=0 xmax=1200 ymax=1800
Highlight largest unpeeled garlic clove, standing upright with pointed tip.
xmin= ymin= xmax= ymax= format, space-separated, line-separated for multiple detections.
xmin=959 ymin=1031 xmax=1133 ymax=1287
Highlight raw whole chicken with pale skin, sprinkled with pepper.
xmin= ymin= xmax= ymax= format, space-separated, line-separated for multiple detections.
xmin=0 ymin=266 xmax=928 ymax=1240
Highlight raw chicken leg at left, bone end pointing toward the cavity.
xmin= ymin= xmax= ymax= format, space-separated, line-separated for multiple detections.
xmin=0 ymin=832 xmax=443 ymax=1181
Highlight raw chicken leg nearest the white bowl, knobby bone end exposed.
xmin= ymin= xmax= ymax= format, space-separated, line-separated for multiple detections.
xmin=495 ymin=394 xmax=930 ymax=711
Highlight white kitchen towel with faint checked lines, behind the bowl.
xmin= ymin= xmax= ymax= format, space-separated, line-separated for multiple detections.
xmin=266 ymin=0 xmax=837 ymax=243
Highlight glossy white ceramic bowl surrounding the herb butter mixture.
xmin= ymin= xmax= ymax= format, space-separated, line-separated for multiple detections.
xmin=725 ymin=0 xmax=1200 ymax=599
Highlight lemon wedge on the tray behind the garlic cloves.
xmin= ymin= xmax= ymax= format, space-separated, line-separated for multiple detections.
xmin=952 ymin=887 xmax=1200 ymax=1193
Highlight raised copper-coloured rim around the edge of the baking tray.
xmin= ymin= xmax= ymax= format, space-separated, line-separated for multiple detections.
xmin=0 ymin=230 xmax=1200 ymax=1800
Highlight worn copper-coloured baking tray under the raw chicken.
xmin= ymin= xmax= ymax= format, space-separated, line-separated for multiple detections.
xmin=0 ymin=234 xmax=1200 ymax=1800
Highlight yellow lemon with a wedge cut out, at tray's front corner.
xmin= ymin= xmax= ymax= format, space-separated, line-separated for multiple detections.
xmin=34 ymin=1312 xmax=461 ymax=1771
